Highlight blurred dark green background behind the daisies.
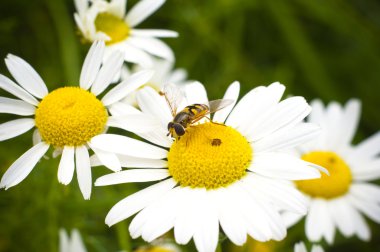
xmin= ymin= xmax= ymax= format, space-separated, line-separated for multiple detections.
xmin=0 ymin=0 xmax=380 ymax=251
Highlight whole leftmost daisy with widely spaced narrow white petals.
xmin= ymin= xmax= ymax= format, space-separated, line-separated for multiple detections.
xmin=0 ymin=42 xmax=153 ymax=199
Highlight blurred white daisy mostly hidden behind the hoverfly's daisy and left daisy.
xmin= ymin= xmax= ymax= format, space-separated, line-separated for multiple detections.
xmin=121 ymin=59 xmax=190 ymax=105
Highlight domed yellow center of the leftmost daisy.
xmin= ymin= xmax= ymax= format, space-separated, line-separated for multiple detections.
xmin=35 ymin=87 xmax=108 ymax=147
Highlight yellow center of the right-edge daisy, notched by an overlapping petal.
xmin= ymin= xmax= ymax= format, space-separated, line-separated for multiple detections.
xmin=296 ymin=151 xmax=352 ymax=199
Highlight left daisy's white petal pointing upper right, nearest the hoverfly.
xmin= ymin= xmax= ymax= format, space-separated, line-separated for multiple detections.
xmin=102 ymin=70 xmax=154 ymax=106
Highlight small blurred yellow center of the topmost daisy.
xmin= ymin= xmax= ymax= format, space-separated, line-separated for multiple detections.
xmin=95 ymin=12 xmax=131 ymax=45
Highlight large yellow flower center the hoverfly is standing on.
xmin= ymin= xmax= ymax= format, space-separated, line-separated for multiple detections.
xmin=168 ymin=122 xmax=253 ymax=189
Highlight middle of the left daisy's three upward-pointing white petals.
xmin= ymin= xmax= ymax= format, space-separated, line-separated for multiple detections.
xmin=91 ymin=51 xmax=124 ymax=96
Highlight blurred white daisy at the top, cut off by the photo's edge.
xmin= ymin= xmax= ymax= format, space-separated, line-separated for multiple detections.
xmin=74 ymin=0 xmax=178 ymax=67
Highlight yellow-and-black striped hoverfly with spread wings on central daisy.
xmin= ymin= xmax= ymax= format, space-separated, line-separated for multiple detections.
xmin=160 ymin=85 xmax=234 ymax=140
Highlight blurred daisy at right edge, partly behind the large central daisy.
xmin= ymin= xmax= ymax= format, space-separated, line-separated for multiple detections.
xmin=284 ymin=99 xmax=380 ymax=244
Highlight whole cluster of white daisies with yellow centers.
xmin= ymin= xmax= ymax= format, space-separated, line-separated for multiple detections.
xmin=0 ymin=0 xmax=380 ymax=252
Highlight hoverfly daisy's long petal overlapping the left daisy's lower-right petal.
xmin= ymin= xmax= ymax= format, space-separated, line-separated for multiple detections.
xmin=91 ymin=134 xmax=168 ymax=159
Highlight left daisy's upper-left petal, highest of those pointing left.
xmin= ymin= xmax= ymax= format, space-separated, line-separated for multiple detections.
xmin=5 ymin=54 xmax=48 ymax=98
